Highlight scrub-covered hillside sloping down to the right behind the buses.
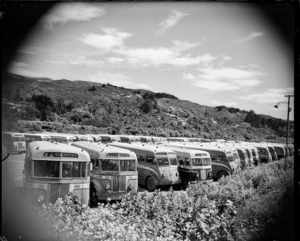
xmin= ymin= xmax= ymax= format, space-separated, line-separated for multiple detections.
xmin=2 ymin=73 xmax=293 ymax=141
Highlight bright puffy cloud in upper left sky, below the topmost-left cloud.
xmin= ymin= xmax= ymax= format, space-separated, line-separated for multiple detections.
xmin=80 ymin=27 xmax=131 ymax=52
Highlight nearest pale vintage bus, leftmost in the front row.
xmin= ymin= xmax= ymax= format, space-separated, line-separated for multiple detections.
xmin=23 ymin=141 xmax=90 ymax=205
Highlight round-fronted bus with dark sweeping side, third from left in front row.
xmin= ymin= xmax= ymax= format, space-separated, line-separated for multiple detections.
xmin=109 ymin=143 xmax=180 ymax=191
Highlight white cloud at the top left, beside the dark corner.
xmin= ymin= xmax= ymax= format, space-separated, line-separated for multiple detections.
xmin=43 ymin=3 xmax=105 ymax=29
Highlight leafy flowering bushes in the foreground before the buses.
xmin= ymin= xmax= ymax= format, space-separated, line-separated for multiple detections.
xmin=34 ymin=162 xmax=294 ymax=240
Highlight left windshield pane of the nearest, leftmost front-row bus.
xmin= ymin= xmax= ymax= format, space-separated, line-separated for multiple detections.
xmin=33 ymin=161 xmax=59 ymax=178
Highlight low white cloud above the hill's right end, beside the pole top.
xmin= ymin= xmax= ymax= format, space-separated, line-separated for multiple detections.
xmin=239 ymin=88 xmax=294 ymax=105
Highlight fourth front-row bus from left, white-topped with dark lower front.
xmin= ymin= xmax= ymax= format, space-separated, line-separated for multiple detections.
xmin=171 ymin=147 xmax=212 ymax=187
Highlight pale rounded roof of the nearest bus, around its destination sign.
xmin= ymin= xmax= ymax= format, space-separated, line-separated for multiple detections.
xmin=28 ymin=141 xmax=90 ymax=162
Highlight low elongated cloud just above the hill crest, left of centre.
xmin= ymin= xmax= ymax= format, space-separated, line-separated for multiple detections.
xmin=88 ymin=72 xmax=150 ymax=89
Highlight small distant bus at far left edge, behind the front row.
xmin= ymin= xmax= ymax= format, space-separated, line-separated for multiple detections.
xmin=2 ymin=132 xmax=26 ymax=154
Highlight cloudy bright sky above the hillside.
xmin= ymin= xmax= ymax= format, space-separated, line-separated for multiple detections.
xmin=8 ymin=2 xmax=294 ymax=120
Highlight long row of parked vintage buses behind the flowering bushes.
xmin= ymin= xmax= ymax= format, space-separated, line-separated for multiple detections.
xmin=2 ymin=133 xmax=293 ymax=207
